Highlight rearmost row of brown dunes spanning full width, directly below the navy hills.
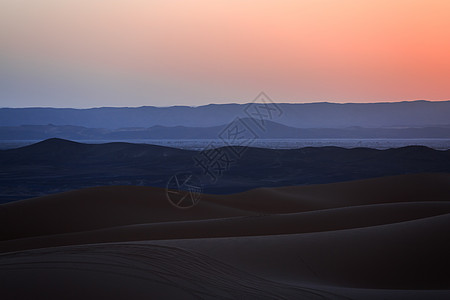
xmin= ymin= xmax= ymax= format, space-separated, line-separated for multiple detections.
xmin=0 ymin=174 xmax=450 ymax=240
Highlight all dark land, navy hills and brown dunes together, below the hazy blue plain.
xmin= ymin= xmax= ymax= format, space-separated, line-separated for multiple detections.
xmin=0 ymin=118 xmax=450 ymax=299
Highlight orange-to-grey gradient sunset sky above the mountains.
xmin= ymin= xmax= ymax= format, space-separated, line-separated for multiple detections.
xmin=0 ymin=0 xmax=450 ymax=108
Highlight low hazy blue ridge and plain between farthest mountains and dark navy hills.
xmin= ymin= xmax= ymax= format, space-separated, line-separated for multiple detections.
xmin=0 ymin=118 xmax=450 ymax=140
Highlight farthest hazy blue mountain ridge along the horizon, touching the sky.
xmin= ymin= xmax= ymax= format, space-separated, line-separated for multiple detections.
xmin=0 ymin=101 xmax=450 ymax=129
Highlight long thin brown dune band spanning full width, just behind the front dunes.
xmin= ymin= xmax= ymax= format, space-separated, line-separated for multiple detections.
xmin=0 ymin=202 xmax=450 ymax=252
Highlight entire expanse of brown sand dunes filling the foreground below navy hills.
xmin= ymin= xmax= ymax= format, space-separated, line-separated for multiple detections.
xmin=0 ymin=173 xmax=450 ymax=299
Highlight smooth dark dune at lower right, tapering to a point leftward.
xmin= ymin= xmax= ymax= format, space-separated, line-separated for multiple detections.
xmin=152 ymin=214 xmax=450 ymax=290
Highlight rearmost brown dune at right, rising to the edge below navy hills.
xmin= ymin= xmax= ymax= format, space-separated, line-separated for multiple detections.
xmin=215 ymin=173 xmax=450 ymax=213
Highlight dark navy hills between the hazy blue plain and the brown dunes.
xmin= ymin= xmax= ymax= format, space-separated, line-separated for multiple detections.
xmin=0 ymin=139 xmax=450 ymax=201
